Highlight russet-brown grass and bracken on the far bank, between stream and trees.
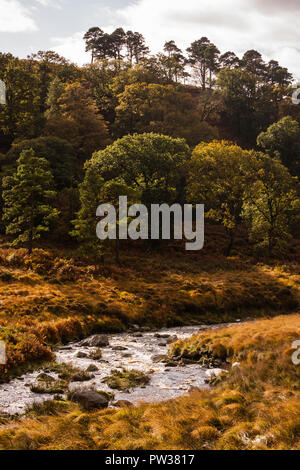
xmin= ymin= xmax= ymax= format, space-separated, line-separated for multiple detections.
xmin=0 ymin=227 xmax=300 ymax=381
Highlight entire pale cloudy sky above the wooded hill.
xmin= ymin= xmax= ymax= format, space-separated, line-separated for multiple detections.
xmin=0 ymin=0 xmax=300 ymax=80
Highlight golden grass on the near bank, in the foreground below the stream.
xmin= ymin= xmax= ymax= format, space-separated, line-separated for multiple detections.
xmin=0 ymin=314 xmax=300 ymax=450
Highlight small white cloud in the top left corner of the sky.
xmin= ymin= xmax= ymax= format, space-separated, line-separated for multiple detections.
xmin=0 ymin=0 xmax=38 ymax=33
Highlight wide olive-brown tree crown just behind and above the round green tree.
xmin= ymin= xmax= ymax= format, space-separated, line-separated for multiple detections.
xmin=114 ymin=83 xmax=217 ymax=146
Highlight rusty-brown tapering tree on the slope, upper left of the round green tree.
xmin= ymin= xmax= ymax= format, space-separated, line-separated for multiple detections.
xmin=45 ymin=82 xmax=110 ymax=160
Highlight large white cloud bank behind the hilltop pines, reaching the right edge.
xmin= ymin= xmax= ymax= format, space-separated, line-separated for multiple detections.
xmin=49 ymin=0 xmax=300 ymax=78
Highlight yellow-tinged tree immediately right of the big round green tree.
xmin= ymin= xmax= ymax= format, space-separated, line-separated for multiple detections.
xmin=187 ymin=141 xmax=253 ymax=256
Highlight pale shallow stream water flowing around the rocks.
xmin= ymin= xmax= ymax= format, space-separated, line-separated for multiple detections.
xmin=0 ymin=325 xmax=227 ymax=414
